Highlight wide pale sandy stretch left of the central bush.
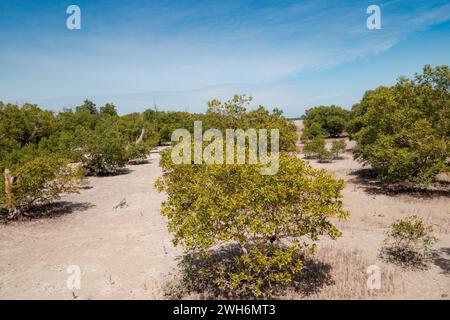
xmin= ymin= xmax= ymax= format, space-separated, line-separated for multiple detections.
xmin=0 ymin=153 xmax=179 ymax=299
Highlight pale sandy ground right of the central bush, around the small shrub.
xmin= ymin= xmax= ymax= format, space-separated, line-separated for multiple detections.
xmin=295 ymin=120 xmax=450 ymax=299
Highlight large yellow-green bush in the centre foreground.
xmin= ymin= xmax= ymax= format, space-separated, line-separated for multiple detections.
xmin=156 ymin=152 xmax=348 ymax=297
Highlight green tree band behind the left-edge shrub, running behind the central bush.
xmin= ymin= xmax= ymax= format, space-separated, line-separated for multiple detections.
xmin=0 ymin=96 xmax=296 ymax=221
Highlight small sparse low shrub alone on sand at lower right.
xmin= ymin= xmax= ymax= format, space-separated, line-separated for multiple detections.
xmin=381 ymin=216 xmax=436 ymax=267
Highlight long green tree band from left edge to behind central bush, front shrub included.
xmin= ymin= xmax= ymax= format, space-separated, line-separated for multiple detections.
xmin=0 ymin=95 xmax=296 ymax=217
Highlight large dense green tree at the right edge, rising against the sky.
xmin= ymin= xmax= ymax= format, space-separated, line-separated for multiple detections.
xmin=351 ymin=66 xmax=450 ymax=183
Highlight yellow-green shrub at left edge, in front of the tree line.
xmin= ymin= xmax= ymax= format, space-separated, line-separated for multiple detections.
xmin=2 ymin=156 xmax=83 ymax=218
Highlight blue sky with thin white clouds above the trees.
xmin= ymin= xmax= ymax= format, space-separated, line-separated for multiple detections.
xmin=0 ymin=0 xmax=450 ymax=117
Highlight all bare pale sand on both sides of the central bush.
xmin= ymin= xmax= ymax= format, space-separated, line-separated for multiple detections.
xmin=0 ymin=122 xmax=450 ymax=299
